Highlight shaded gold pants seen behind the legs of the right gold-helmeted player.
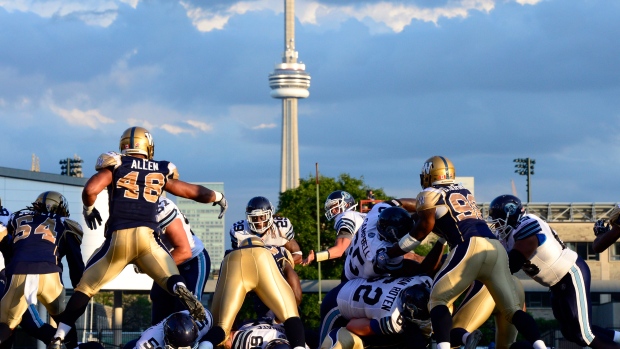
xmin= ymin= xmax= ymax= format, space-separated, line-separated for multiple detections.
xmin=452 ymin=275 xmax=525 ymax=349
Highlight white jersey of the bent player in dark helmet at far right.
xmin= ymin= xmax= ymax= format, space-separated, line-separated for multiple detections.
xmin=502 ymin=214 xmax=578 ymax=287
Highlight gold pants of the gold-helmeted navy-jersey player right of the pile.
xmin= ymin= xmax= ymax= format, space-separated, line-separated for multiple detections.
xmin=429 ymin=236 xmax=522 ymax=323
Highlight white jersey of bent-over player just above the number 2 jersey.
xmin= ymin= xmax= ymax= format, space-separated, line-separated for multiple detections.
xmin=344 ymin=201 xmax=403 ymax=280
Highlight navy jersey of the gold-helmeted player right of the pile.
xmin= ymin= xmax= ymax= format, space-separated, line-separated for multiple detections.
xmin=417 ymin=184 xmax=497 ymax=247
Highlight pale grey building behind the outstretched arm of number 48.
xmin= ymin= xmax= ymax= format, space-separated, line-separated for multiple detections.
xmin=176 ymin=182 xmax=227 ymax=278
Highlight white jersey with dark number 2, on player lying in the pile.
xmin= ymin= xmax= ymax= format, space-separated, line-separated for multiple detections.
xmin=337 ymin=276 xmax=433 ymax=334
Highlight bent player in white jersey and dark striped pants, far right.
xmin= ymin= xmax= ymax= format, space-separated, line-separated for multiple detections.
xmin=489 ymin=195 xmax=620 ymax=349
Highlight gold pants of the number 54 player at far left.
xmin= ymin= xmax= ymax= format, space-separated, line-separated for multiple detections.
xmin=0 ymin=273 xmax=65 ymax=330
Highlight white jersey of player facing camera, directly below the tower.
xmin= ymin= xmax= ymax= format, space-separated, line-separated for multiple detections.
xmin=230 ymin=216 xmax=295 ymax=248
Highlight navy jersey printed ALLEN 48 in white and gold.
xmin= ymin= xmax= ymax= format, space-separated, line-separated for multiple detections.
xmin=95 ymin=152 xmax=177 ymax=231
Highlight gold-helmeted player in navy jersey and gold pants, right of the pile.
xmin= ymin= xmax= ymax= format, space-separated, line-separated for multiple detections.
xmin=377 ymin=156 xmax=546 ymax=349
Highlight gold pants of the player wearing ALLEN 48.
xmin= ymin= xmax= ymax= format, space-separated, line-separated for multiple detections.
xmin=75 ymin=227 xmax=179 ymax=297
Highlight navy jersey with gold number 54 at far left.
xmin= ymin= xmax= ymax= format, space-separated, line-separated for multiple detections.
xmin=6 ymin=210 xmax=66 ymax=275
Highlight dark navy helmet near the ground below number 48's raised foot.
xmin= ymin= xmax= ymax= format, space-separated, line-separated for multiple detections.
xmin=164 ymin=312 xmax=199 ymax=349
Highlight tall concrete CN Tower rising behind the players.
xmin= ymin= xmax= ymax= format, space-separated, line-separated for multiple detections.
xmin=269 ymin=0 xmax=310 ymax=192
